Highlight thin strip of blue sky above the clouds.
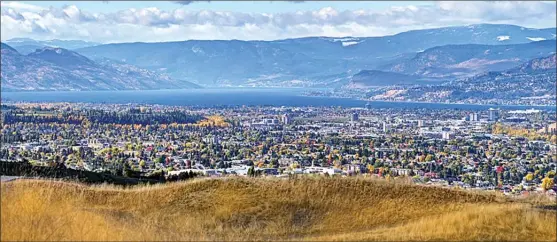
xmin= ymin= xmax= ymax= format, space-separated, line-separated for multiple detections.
xmin=22 ymin=1 xmax=432 ymax=13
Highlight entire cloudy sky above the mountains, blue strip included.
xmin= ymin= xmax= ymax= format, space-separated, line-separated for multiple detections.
xmin=0 ymin=1 xmax=557 ymax=43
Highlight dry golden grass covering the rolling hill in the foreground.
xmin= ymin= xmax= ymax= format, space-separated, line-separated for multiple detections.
xmin=1 ymin=178 xmax=557 ymax=241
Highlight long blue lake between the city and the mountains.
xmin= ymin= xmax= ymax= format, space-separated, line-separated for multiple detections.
xmin=2 ymin=88 xmax=555 ymax=111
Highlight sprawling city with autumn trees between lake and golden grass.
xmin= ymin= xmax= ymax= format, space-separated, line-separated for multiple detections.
xmin=0 ymin=102 xmax=557 ymax=194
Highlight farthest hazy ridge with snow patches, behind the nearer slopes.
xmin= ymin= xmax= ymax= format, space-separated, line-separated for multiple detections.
xmin=76 ymin=24 xmax=555 ymax=86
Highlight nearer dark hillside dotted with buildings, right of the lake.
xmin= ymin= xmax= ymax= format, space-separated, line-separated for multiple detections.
xmin=368 ymin=54 xmax=557 ymax=105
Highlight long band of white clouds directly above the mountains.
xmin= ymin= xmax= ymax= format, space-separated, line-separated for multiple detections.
xmin=1 ymin=1 xmax=556 ymax=42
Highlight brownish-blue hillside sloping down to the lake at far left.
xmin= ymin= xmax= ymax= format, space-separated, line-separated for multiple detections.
xmin=1 ymin=43 xmax=200 ymax=91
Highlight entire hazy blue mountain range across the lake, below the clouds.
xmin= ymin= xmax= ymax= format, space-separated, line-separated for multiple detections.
xmin=2 ymin=24 xmax=556 ymax=90
